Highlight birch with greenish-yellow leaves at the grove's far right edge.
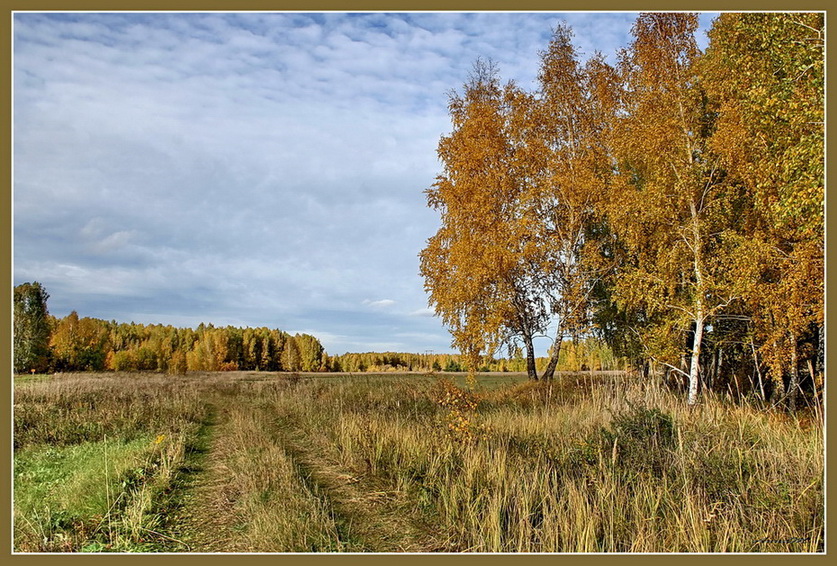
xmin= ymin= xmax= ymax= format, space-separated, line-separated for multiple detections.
xmin=702 ymin=13 xmax=825 ymax=410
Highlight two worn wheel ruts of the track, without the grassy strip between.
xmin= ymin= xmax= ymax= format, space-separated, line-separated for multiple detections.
xmin=163 ymin=403 xmax=445 ymax=553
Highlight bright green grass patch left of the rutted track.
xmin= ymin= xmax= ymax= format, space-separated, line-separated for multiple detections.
xmin=14 ymin=435 xmax=192 ymax=552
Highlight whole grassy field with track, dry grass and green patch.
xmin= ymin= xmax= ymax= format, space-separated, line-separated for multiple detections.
xmin=14 ymin=372 xmax=824 ymax=552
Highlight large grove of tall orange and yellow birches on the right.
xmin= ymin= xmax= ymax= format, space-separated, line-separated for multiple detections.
xmin=420 ymin=13 xmax=825 ymax=408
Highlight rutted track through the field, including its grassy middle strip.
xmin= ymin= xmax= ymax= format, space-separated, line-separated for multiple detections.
xmin=172 ymin=390 xmax=442 ymax=553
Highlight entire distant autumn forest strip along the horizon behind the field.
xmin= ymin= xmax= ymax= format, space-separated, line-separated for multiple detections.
xmin=9 ymin=282 xmax=622 ymax=374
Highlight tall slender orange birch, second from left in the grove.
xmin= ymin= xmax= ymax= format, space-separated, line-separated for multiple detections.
xmin=521 ymin=25 xmax=615 ymax=379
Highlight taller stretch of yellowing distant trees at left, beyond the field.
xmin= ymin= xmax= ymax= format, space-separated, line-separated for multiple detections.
xmin=14 ymin=282 xmax=330 ymax=374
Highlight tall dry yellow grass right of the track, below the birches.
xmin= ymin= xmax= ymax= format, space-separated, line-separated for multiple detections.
xmin=268 ymin=379 xmax=824 ymax=552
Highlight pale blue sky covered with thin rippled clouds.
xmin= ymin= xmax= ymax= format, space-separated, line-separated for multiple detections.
xmin=12 ymin=12 xmax=714 ymax=355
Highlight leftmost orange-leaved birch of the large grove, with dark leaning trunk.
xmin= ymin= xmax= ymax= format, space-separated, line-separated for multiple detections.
xmin=420 ymin=61 xmax=548 ymax=379
